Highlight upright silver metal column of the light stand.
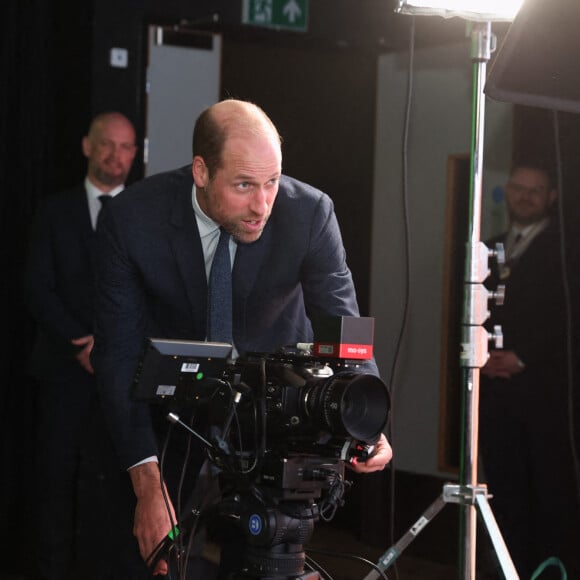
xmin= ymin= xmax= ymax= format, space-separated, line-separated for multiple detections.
xmin=460 ymin=22 xmax=492 ymax=580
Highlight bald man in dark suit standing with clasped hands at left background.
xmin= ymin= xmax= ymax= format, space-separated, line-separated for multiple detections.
xmin=25 ymin=112 xmax=136 ymax=580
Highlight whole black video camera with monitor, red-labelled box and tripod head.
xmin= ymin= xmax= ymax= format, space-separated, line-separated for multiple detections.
xmin=134 ymin=317 xmax=389 ymax=578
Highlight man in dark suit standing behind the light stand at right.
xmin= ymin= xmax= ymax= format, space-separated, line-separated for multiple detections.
xmin=480 ymin=161 xmax=580 ymax=578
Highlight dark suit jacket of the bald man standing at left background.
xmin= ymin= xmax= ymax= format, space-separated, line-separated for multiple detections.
xmin=24 ymin=185 xmax=96 ymax=380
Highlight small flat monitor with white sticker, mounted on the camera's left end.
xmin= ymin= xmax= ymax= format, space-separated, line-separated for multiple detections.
xmin=132 ymin=338 xmax=232 ymax=403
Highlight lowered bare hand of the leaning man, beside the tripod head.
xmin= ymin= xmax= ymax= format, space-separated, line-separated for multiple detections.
xmin=129 ymin=462 xmax=175 ymax=576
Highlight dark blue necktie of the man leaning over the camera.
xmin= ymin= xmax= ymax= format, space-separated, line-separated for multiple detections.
xmin=207 ymin=228 xmax=232 ymax=344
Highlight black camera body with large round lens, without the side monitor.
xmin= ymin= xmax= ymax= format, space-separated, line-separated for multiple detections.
xmin=222 ymin=350 xmax=389 ymax=450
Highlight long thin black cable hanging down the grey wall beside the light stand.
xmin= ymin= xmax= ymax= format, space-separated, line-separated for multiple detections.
xmin=387 ymin=16 xmax=415 ymax=579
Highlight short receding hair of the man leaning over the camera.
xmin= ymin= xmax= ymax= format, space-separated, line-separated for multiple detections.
xmin=192 ymin=99 xmax=282 ymax=179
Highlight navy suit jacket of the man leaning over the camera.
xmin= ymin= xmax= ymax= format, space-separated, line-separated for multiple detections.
xmin=93 ymin=166 xmax=376 ymax=467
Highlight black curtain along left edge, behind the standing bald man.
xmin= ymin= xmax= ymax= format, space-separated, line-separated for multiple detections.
xmin=0 ymin=0 xmax=91 ymax=573
